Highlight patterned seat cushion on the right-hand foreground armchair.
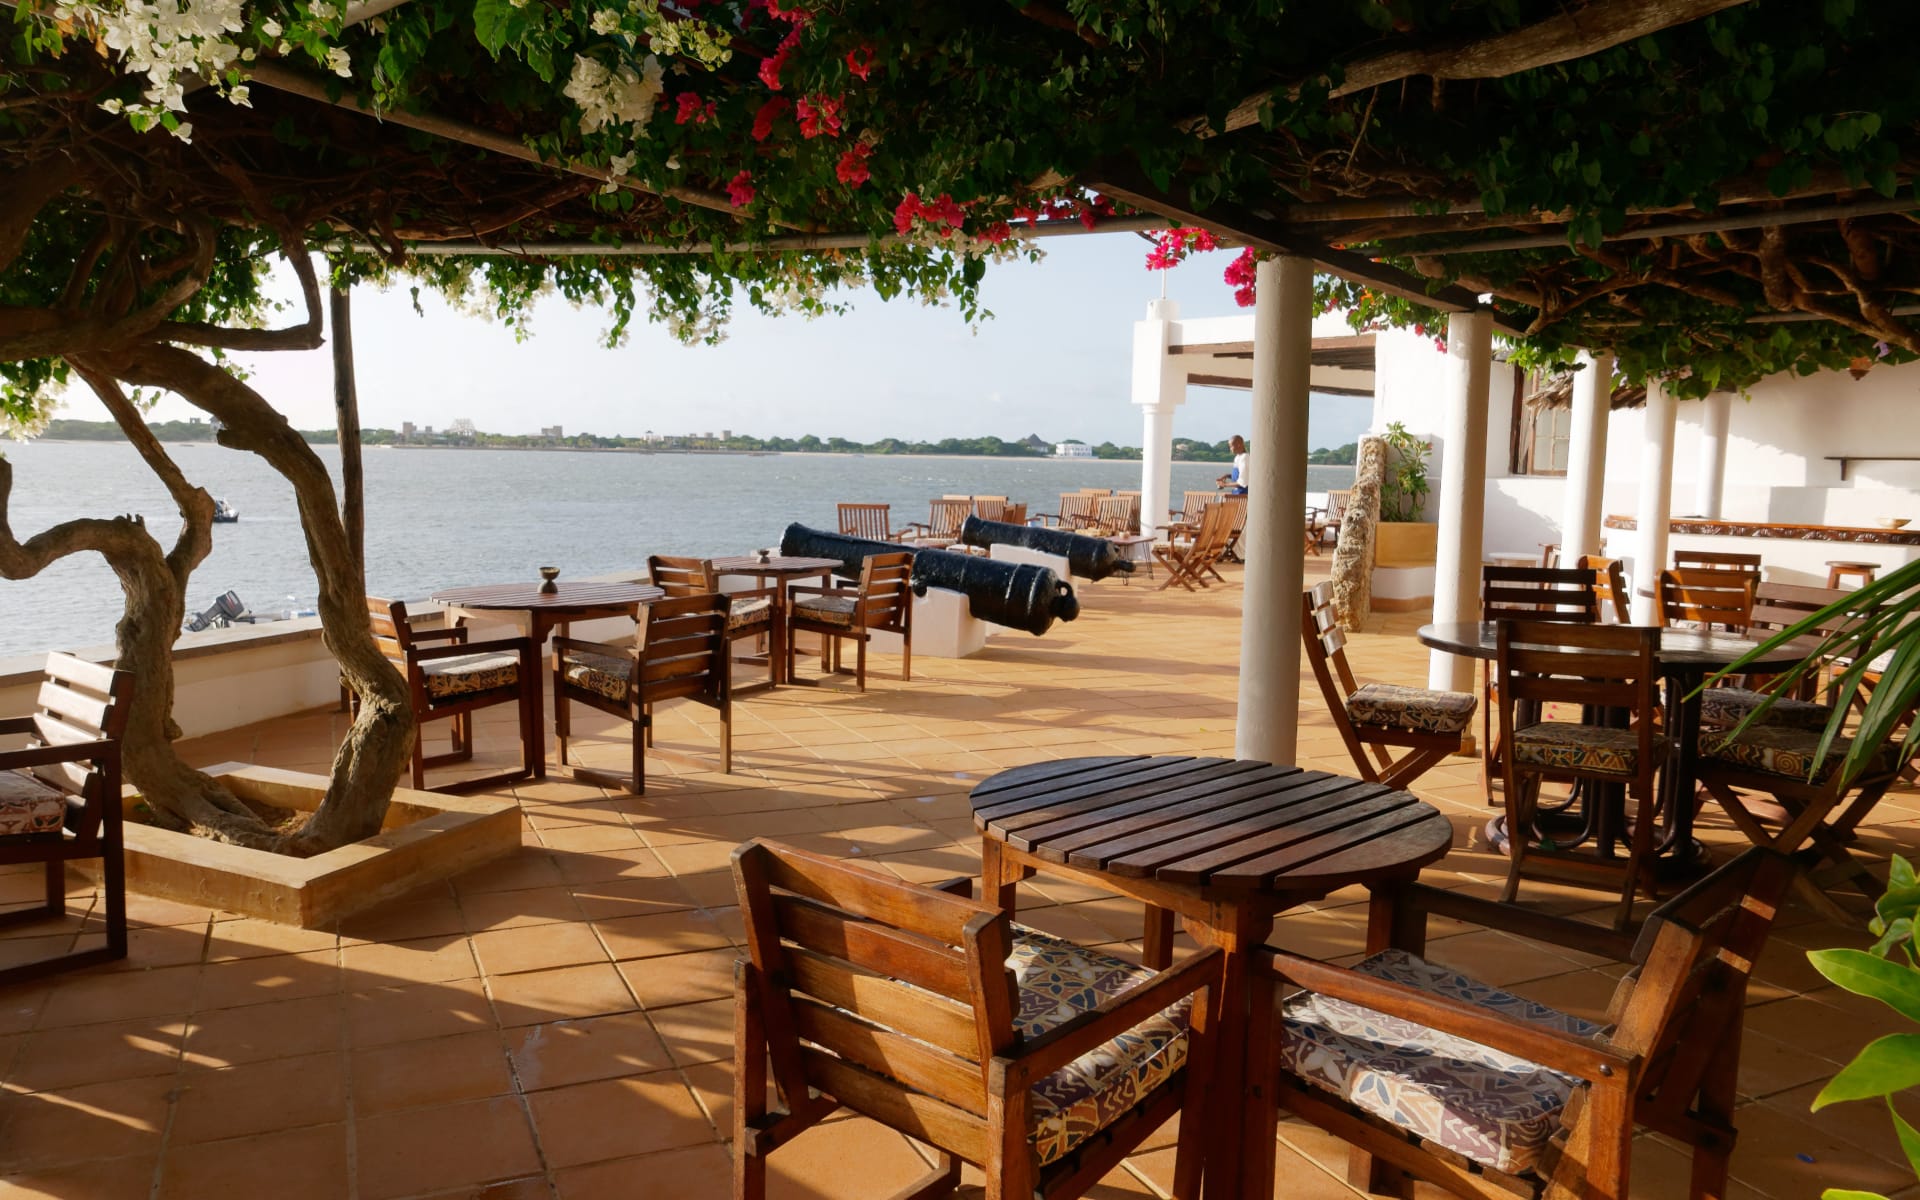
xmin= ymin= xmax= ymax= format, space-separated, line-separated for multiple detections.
xmin=1281 ymin=950 xmax=1601 ymax=1173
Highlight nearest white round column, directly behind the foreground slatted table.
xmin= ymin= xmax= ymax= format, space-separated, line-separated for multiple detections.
xmin=1233 ymin=255 xmax=1313 ymax=762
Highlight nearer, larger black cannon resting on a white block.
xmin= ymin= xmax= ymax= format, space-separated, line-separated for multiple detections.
xmin=780 ymin=524 xmax=1079 ymax=636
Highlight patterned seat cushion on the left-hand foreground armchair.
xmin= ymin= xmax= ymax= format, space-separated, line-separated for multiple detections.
xmin=1006 ymin=925 xmax=1188 ymax=1165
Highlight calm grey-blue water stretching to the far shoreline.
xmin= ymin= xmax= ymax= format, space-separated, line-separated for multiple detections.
xmin=0 ymin=442 xmax=1354 ymax=657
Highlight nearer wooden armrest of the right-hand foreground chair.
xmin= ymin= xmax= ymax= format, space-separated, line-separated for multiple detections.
xmin=1254 ymin=947 xmax=1640 ymax=1081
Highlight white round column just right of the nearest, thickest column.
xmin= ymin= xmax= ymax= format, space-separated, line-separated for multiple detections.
xmin=1427 ymin=313 xmax=1494 ymax=691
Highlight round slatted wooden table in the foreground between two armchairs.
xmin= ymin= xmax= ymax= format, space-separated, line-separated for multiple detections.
xmin=972 ymin=756 xmax=1453 ymax=1200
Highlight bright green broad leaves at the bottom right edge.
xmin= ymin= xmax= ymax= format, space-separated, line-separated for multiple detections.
xmin=1807 ymin=854 xmax=1920 ymax=1200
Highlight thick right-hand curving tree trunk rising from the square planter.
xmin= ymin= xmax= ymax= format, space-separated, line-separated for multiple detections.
xmin=102 ymin=346 xmax=415 ymax=854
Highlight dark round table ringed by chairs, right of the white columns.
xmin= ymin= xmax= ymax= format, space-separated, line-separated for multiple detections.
xmin=1417 ymin=620 xmax=1812 ymax=874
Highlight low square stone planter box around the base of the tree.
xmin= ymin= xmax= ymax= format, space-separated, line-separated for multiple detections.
xmin=103 ymin=762 xmax=520 ymax=929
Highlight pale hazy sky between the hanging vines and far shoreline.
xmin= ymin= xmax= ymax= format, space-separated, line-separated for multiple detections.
xmin=61 ymin=234 xmax=1371 ymax=447
